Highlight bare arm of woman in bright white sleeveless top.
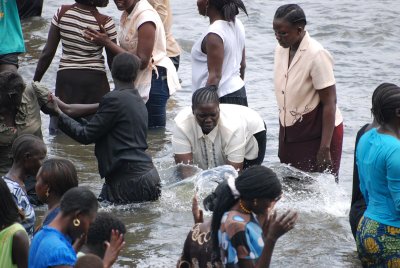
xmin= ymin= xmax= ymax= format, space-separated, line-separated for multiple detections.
xmin=205 ymin=33 xmax=224 ymax=87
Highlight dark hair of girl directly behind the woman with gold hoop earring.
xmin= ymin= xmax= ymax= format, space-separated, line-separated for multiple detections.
xmin=41 ymin=158 xmax=78 ymax=198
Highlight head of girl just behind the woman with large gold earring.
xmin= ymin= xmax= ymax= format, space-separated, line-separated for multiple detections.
xmin=35 ymin=158 xmax=78 ymax=203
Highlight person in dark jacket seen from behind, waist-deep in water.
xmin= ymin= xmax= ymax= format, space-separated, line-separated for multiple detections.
xmin=51 ymin=53 xmax=161 ymax=203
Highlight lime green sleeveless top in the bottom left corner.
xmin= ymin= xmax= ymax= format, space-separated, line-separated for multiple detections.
xmin=0 ymin=222 xmax=28 ymax=268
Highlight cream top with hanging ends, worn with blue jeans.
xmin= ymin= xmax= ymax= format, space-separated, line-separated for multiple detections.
xmin=119 ymin=0 xmax=181 ymax=102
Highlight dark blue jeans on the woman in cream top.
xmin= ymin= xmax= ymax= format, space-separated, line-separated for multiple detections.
xmin=146 ymin=66 xmax=169 ymax=128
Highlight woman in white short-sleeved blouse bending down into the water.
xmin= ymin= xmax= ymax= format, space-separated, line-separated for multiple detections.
xmin=172 ymin=86 xmax=266 ymax=171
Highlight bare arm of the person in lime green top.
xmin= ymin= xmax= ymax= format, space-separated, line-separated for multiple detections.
xmin=12 ymin=231 xmax=29 ymax=268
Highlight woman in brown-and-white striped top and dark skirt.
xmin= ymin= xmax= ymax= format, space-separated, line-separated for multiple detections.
xmin=33 ymin=0 xmax=117 ymax=133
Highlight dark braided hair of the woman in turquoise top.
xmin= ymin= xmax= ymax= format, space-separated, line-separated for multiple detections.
xmin=371 ymin=83 xmax=400 ymax=125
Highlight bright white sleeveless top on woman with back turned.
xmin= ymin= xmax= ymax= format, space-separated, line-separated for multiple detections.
xmin=191 ymin=18 xmax=245 ymax=97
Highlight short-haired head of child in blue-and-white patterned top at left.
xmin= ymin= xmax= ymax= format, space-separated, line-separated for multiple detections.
xmin=11 ymin=134 xmax=47 ymax=176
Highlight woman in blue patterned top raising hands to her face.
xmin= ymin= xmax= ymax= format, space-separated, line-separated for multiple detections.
xmin=211 ymin=166 xmax=297 ymax=268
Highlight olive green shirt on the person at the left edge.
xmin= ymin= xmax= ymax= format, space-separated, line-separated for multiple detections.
xmin=0 ymin=82 xmax=49 ymax=176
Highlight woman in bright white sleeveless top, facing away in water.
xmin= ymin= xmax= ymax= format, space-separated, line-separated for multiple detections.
xmin=192 ymin=0 xmax=247 ymax=106
